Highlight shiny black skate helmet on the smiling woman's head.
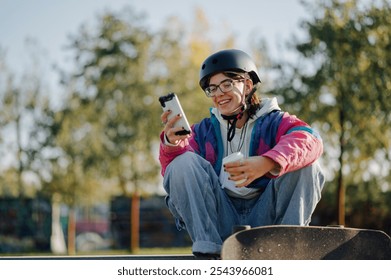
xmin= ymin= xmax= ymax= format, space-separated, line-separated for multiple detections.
xmin=200 ymin=49 xmax=261 ymax=89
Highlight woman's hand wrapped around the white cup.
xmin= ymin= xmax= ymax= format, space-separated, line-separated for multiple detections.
xmin=224 ymin=156 xmax=279 ymax=187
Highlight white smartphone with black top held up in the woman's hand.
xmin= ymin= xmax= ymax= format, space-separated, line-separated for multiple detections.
xmin=159 ymin=93 xmax=191 ymax=135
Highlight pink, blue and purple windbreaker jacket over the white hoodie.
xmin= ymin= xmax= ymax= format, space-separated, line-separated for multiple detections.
xmin=159 ymin=98 xmax=323 ymax=192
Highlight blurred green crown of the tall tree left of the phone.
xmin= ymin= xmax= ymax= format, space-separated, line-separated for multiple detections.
xmin=51 ymin=10 xmax=160 ymax=201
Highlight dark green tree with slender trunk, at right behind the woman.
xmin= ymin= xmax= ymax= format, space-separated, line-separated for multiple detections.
xmin=271 ymin=0 xmax=391 ymax=224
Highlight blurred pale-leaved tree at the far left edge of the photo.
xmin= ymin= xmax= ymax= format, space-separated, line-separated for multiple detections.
xmin=0 ymin=40 xmax=49 ymax=197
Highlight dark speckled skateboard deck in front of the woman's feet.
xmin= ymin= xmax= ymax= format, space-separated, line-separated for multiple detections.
xmin=221 ymin=226 xmax=391 ymax=260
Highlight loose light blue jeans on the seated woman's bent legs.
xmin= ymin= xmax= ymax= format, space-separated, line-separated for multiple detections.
xmin=163 ymin=152 xmax=324 ymax=254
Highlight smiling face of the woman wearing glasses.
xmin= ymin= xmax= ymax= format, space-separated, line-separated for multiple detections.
xmin=209 ymin=73 xmax=248 ymax=116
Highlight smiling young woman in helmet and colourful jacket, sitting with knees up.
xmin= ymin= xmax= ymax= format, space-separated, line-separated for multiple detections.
xmin=159 ymin=49 xmax=324 ymax=257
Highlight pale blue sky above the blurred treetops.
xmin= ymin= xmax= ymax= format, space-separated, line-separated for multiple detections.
xmin=0 ymin=0 xmax=306 ymax=84
